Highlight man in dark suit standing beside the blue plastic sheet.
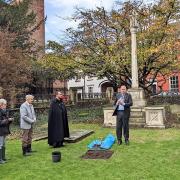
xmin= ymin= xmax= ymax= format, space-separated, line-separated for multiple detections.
xmin=113 ymin=85 xmax=133 ymax=145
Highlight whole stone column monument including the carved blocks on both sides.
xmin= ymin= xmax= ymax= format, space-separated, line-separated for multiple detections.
xmin=104 ymin=12 xmax=166 ymax=128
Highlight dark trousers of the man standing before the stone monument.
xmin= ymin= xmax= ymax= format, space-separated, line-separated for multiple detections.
xmin=116 ymin=111 xmax=129 ymax=140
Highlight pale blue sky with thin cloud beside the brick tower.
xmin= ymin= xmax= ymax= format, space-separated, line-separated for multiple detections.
xmin=45 ymin=0 xmax=114 ymax=41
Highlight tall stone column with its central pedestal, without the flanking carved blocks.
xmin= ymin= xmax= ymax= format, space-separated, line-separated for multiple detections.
xmin=128 ymin=11 xmax=146 ymax=127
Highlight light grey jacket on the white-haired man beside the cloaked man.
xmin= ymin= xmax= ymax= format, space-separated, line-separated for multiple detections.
xmin=20 ymin=102 xmax=36 ymax=129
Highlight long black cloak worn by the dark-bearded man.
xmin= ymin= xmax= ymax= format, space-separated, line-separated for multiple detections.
xmin=48 ymin=99 xmax=69 ymax=145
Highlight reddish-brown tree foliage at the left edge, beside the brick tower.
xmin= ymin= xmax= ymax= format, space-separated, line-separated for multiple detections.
xmin=0 ymin=32 xmax=31 ymax=99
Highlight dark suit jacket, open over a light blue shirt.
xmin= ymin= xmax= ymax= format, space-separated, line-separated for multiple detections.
xmin=113 ymin=93 xmax=133 ymax=118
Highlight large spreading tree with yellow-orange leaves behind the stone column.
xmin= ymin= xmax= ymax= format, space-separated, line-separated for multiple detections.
xmin=63 ymin=0 xmax=180 ymax=93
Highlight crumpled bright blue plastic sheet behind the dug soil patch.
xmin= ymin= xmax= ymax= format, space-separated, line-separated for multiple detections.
xmin=88 ymin=134 xmax=116 ymax=149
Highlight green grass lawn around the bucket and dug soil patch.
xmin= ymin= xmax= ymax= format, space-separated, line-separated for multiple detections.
xmin=0 ymin=124 xmax=180 ymax=180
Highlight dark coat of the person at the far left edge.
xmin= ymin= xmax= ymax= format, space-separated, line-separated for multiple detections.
xmin=0 ymin=109 xmax=11 ymax=136
